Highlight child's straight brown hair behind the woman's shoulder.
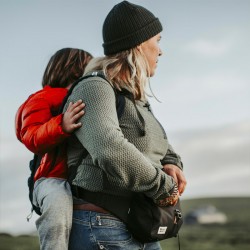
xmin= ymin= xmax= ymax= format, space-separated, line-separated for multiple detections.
xmin=42 ymin=48 xmax=92 ymax=88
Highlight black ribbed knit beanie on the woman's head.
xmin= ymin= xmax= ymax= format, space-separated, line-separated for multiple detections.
xmin=102 ymin=1 xmax=162 ymax=55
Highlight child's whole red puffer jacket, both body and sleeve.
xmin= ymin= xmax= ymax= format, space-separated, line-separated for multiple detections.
xmin=15 ymin=86 xmax=69 ymax=181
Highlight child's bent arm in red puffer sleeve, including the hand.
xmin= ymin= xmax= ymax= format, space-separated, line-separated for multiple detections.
xmin=17 ymin=98 xmax=84 ymax=154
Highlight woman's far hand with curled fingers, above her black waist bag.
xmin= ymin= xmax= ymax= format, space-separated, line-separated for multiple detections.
xmin=163 ymin=164 xmax=187 ymax=195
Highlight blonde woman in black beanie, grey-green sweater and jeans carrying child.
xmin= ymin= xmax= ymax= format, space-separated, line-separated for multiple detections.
xmin=65 ymin=1 xmax=186 ymax=250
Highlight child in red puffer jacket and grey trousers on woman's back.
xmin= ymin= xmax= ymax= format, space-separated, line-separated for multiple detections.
xmin=16 ymin=48 xmax=92 ymax=250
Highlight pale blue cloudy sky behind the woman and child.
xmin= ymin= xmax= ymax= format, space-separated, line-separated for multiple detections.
xmin=0 ymin=0 xmax=250 ymax=233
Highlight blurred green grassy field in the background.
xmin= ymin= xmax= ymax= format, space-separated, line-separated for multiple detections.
xmin=0 ymin=198 xmax=250 ymax=250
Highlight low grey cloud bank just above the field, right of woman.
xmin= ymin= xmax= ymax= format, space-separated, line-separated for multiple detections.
xmin=172 ymin=121 xmax=250 ymax=198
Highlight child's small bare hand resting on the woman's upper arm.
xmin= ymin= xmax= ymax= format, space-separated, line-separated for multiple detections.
xmin=62 ymin=100 xmax=85 ymax=133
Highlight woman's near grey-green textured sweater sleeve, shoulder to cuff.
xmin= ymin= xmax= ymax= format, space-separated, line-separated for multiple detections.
xmin=66 ymin=78 xmax=174 ymax=199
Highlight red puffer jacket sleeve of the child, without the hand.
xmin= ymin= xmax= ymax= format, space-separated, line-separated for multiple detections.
xmin=16 ymin=97 xmax=69 ymax=154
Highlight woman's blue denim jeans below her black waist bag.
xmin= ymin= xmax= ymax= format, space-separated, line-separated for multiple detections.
xmin=69 ymin=210 xmax=161 ymax=250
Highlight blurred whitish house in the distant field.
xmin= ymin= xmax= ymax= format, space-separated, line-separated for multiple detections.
xmin=184 ymin=205 xmax=227 ymax=224
